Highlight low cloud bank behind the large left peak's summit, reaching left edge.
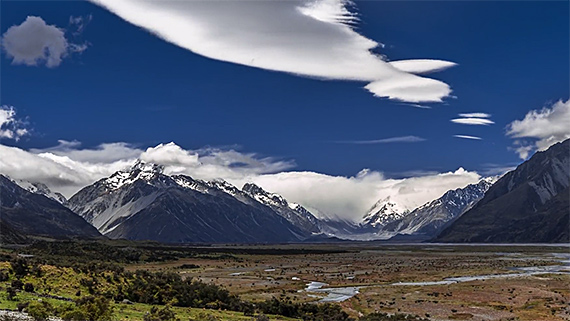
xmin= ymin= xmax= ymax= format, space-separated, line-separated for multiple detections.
xmin=4 ymin=140 xmax=294 ymax=196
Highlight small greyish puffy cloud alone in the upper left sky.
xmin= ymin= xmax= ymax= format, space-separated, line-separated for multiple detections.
xmin=2 ymin=16 xmax=87 ymax=68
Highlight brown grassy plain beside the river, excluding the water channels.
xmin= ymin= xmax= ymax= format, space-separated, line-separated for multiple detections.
xmin=122 ymin=243 xmax=570 ymax=321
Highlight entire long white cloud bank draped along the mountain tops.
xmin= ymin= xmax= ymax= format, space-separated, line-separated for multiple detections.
xmin=0 ymin=141 xmax=480 ymax=222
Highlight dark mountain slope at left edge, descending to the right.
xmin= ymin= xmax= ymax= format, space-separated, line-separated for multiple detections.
xmin=0 ymin=175 xmax=101 ymax=237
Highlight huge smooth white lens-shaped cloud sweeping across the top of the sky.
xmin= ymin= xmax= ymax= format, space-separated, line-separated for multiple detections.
xmin=91 ymin=0 xmax=455 ymax=102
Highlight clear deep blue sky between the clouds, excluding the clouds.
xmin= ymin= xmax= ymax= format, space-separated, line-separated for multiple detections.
xmin=0 ymin=1 xmax=570 ymax=208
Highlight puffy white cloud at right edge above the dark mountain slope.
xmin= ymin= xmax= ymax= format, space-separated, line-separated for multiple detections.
xmin=507 ymin=100 xmax=570 ymax=159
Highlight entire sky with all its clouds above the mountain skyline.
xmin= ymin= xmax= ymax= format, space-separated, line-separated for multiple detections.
xmin=0 ymin=0 xmax=570 ymax=220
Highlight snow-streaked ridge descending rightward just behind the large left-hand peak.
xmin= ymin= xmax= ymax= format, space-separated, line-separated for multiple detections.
xmin=242 ymin=183 xmax=321 ymax=234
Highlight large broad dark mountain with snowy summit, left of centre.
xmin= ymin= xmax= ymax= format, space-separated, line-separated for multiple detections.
xmin=69 ymin=162 xmax=307 ymax=243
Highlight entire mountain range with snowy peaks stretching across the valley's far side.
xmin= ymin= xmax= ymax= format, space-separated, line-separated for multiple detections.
xmin=0 ymin=140 xmax=570 ymax=243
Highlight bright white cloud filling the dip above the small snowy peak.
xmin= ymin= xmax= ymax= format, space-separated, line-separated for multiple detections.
xmin=234 ymin=168 xmax=480 ymax=222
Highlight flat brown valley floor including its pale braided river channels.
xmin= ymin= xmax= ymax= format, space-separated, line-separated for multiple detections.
xmin=0 ymin=243 xmax=570 ymax=321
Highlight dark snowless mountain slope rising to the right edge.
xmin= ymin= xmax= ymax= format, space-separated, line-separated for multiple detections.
xmin=434 ymin=140 xmax=570 ymax=243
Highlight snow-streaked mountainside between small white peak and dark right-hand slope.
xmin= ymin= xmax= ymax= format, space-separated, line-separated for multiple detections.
xmin=383 ymin=177 xmax=498 ymax=237
